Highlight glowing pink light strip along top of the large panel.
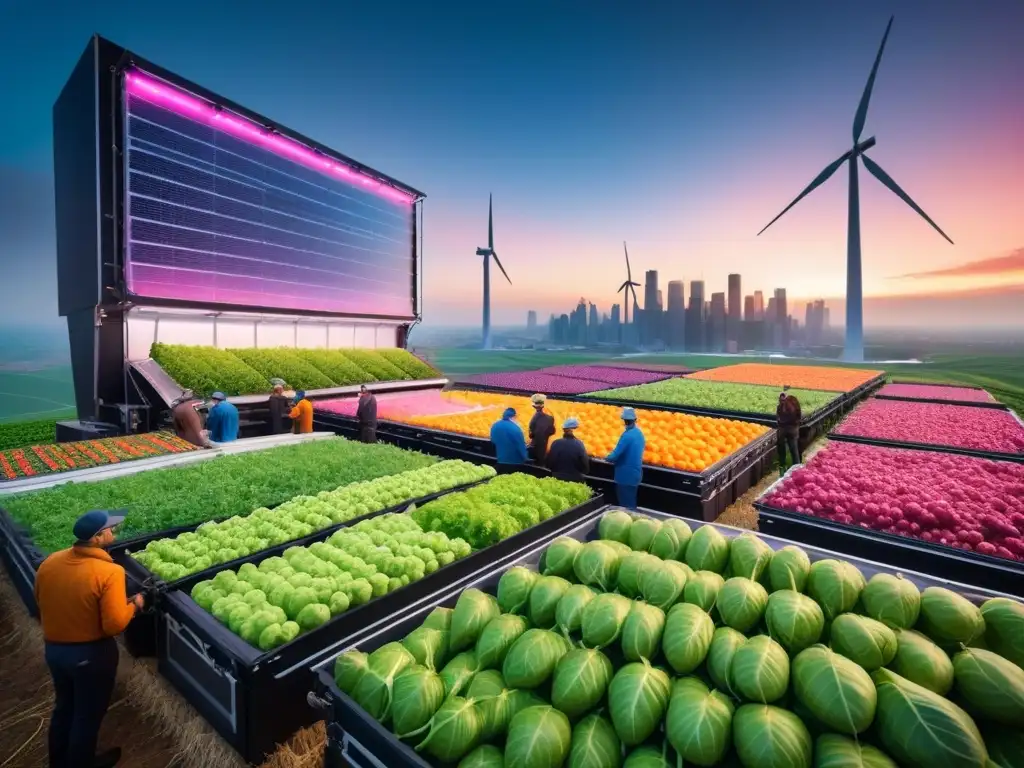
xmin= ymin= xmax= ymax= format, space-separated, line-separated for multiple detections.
xmin=125 ymin=70 xmax=415 ymax=203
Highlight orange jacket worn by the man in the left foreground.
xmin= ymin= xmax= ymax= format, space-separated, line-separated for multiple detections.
xmin=36 ymin=546 xmax=135 ymax=643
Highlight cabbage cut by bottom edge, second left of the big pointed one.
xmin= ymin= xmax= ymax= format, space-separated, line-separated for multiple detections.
xmin=732 ymin=703 xmax=813 ymax=768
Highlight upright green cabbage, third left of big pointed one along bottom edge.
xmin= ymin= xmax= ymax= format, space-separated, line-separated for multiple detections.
xmin=665 ymin=677 xmax=735 ymax=766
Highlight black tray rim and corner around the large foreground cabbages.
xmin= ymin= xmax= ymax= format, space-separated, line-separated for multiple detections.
xmin=312 ymin=507 xmax=1008 ymax=768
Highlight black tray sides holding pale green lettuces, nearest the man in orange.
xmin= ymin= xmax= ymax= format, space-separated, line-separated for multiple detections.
xmin=158 ymin=496 xmax=604 ymax=764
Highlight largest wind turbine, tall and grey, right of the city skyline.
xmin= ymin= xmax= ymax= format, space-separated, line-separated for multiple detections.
xmin=758 ymin=16 xmax=953 ymax=362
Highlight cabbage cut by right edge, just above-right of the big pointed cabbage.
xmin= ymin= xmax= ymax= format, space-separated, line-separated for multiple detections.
xmin=953 ymin=648 xmax=1024 ymax=729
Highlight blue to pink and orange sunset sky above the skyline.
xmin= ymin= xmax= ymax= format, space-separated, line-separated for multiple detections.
xmin=0 ymin=0 xmax=1024 ymax=327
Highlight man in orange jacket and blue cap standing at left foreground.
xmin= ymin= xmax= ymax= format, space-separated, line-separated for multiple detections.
xmin=36 ymin=509 xmax=143 ymax=768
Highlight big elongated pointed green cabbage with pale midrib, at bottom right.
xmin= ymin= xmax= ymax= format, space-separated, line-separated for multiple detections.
xmin=871 ymin=669 xmax=988 ymax=768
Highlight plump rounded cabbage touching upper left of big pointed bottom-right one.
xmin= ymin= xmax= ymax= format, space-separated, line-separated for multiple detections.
xmin=793 ymin=645 xmax=878 ymax=736
